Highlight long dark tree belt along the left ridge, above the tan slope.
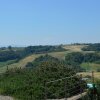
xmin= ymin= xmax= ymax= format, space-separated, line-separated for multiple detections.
xmin=0 ymin=46 xmax=65 ymax=62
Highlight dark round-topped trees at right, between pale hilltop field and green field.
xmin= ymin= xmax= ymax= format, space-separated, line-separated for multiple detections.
xmin=65 ymin=52 xmax=100 ymax=64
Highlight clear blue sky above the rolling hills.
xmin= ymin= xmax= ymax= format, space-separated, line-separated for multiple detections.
xmin=0 ymin=0 xmax=100 ymax=46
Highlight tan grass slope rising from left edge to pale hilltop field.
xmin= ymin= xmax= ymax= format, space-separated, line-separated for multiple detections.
xmin=0 ymin=45 xmax=84 ymax=73
